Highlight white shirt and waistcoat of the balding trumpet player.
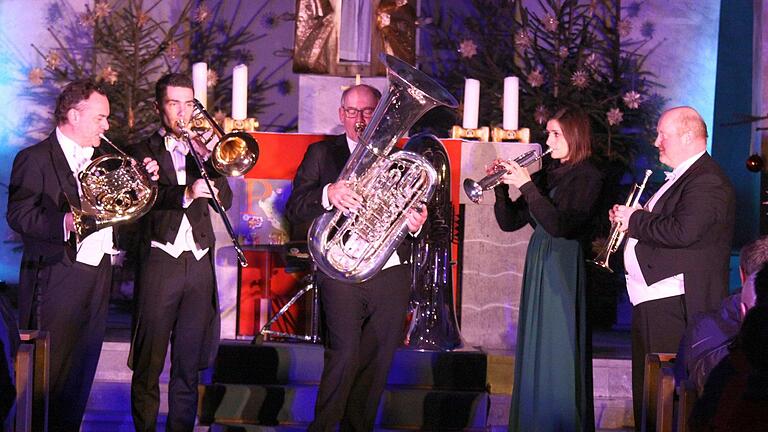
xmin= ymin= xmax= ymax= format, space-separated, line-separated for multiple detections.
xmin=624 ymin=152 xmax=706 ymax=306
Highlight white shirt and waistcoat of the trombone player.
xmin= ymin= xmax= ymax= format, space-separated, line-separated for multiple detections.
xmin=150 ymin=135 xmax=208 ymax=261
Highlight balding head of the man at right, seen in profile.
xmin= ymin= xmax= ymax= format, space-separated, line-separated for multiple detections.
xmin=655 ymin=106 xmax=707 ymax=168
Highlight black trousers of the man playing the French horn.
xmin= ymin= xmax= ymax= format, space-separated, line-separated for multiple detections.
xmin=25 ymin=255 xmax=112 ymax=431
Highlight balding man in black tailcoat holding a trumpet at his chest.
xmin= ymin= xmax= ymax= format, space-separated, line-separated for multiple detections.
xmin=609 ymin=107 xmax=736 ymax=427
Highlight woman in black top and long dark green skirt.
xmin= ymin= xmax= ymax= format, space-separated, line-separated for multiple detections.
xmin=494 ymin=109 xmax=603 ymax=431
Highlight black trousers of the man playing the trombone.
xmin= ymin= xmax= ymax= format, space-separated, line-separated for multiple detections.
xmin=131 ymin=248 xmax=217 ymax=432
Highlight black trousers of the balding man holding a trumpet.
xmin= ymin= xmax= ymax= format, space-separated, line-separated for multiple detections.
xmin=632 ymin=295 xmax=687 ymax=431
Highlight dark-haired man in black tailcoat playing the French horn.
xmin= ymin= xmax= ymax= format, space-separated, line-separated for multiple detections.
xmin=6 ymin=80 xmax=157 ymax=431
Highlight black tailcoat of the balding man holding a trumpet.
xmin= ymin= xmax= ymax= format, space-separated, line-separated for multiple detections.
xmin=628 ymin=153 xmax=736 ymax=317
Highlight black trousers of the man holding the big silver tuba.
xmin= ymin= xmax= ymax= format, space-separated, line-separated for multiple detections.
xmin=309 ymin=265 xmax=410 ymax=431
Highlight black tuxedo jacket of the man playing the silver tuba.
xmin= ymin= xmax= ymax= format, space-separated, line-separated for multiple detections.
xmin=285 ymin=134 xmax=414 ymax=264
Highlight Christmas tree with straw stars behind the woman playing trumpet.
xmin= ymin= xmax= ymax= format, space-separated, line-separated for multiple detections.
xmin=422 ymin=0 xmax=664 ymax=165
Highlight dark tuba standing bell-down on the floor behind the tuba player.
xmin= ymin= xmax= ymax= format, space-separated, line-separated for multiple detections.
xmin=405 ymin=134 xmax=462 ymax=351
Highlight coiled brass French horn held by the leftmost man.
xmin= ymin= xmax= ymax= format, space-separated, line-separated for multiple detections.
xmin=70 ymin=135 xmax=157 ymax=243
